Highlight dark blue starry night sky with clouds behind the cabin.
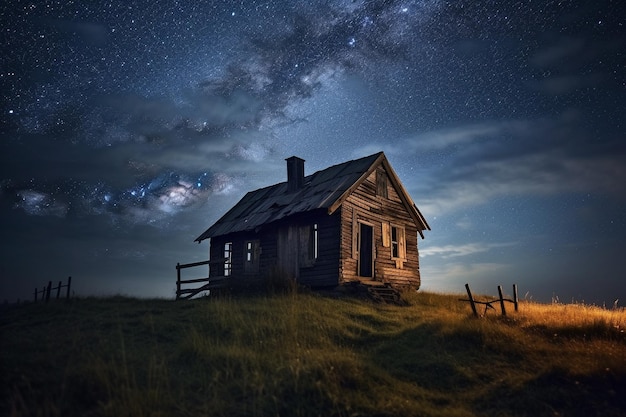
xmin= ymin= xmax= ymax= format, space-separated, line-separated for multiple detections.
xmin=0 ymin=0 xmax=626 ymax=305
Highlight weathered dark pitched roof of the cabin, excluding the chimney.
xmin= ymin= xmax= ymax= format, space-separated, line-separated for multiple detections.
xmin=196 ymin=152 xmax=430 ymax=242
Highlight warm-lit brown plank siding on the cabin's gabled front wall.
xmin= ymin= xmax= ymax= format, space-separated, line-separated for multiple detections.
xmin=340 ymin=166 xmax=420 ymax=288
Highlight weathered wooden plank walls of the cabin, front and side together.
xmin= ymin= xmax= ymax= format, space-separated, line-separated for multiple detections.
xmin=202 ymin=159 xmax=420 ymax=288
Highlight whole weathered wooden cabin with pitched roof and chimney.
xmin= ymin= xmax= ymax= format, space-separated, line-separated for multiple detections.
xmin=196 ymin=152 xmax=430 ymax=289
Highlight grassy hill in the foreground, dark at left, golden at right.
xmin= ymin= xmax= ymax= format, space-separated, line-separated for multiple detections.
xmin=0 ymin=292 xmax=626 ymax=416
